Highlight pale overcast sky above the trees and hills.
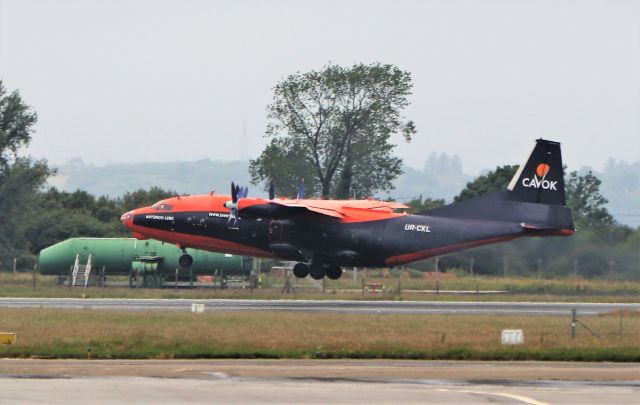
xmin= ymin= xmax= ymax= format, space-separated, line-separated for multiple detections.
xmin=0 ymin=0 xmax=640 ymax=174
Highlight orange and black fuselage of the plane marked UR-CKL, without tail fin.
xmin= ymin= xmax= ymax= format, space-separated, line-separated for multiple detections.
xmin=123 ymin=193 xmax=573 ymax=267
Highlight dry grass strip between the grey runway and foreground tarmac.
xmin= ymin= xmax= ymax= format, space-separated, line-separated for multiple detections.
xmin=0 ymin=309 xmax=640 ymax=361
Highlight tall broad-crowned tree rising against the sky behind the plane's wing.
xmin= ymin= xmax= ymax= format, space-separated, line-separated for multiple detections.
xmin=250 ymin=63 xmax=415 ymax=198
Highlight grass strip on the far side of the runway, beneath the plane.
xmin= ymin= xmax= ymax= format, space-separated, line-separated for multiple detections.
xmin=0 ymin=271 xmax=640 ymax=302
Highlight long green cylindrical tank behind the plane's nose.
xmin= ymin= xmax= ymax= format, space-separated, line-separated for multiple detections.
xmin=39 ymin=238 xmax=252 ymax=275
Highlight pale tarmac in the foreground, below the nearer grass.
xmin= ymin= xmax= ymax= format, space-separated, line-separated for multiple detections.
xmin=0 ymin=359 xmax=640 ymax=405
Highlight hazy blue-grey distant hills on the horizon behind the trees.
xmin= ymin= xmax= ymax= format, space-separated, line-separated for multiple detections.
xmin=49 ymin=154 xmax=640 ymax=227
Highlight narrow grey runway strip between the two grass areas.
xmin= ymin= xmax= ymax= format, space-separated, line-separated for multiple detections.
xmin=0 ymin=298 xmax=640 ymax=316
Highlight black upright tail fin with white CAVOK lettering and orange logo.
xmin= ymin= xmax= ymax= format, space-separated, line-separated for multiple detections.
xmin=508 ymin=139 xmax=566 ymax=205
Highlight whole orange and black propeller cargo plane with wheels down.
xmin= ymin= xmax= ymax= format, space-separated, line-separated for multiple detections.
xmin=121 ymin=139 xmax=575 ymax=280
